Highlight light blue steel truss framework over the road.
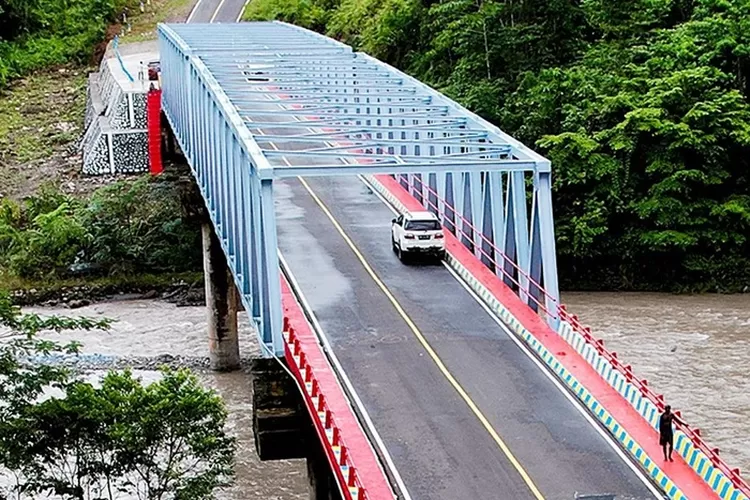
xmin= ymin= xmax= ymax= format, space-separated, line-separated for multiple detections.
xmin=159 ymin=22 xmax=558 ymax=354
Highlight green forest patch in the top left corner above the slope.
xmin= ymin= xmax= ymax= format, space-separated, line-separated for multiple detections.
xmin=0 ymin=0 xmax=137 ymax=88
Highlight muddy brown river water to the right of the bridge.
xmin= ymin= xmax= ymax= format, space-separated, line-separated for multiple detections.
xmin=562 ymin=293 xmax=750 ymax=470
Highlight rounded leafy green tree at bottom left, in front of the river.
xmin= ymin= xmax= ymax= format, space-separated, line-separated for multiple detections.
xmin=17 ymin=369 xmax=234 ymax=500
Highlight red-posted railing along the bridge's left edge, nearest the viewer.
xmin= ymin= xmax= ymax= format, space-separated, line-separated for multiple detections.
xmin=284 ymin=317 xmax=368 ymax=500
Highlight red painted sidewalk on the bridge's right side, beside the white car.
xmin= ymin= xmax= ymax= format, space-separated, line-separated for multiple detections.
xmin=375 ymin=175 xmax=719 ymax=500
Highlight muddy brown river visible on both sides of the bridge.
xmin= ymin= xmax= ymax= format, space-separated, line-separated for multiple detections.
xmin=13 ymin=293 xmax=750 ymax=500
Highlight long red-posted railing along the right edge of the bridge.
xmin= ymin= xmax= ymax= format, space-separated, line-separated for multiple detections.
xmin=397 ymin=172 xmax=750 ymax=496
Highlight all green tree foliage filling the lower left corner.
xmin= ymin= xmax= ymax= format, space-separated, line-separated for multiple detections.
xmin=0 ymin=293 xmax=235 ymax=500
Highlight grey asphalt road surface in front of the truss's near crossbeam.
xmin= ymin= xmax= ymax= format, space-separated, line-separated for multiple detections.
xmin=276 ymin=177 xmax=653 ymax=500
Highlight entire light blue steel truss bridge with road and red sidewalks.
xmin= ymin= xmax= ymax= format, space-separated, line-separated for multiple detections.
xmin=154 ymin=22 xmax=746 ymax=500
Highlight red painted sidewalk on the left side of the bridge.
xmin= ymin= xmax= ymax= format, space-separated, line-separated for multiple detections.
xmin=281 ymin=277 xmax=394 ymax=500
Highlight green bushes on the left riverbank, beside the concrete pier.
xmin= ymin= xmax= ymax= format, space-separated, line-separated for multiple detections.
xmin=0 ymin=177 xmax=201 ymax=281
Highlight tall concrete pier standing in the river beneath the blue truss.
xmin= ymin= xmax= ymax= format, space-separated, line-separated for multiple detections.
xmin=201 ymin=223 xmax=240 ymax=371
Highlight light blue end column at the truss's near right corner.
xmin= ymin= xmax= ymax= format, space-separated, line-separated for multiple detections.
xmin=537 ymin=165 xmax=560 ymax=330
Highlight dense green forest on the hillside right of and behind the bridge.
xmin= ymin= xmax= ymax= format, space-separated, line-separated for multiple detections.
xmin=246 ymin=0 xmax=750 ymax=291
